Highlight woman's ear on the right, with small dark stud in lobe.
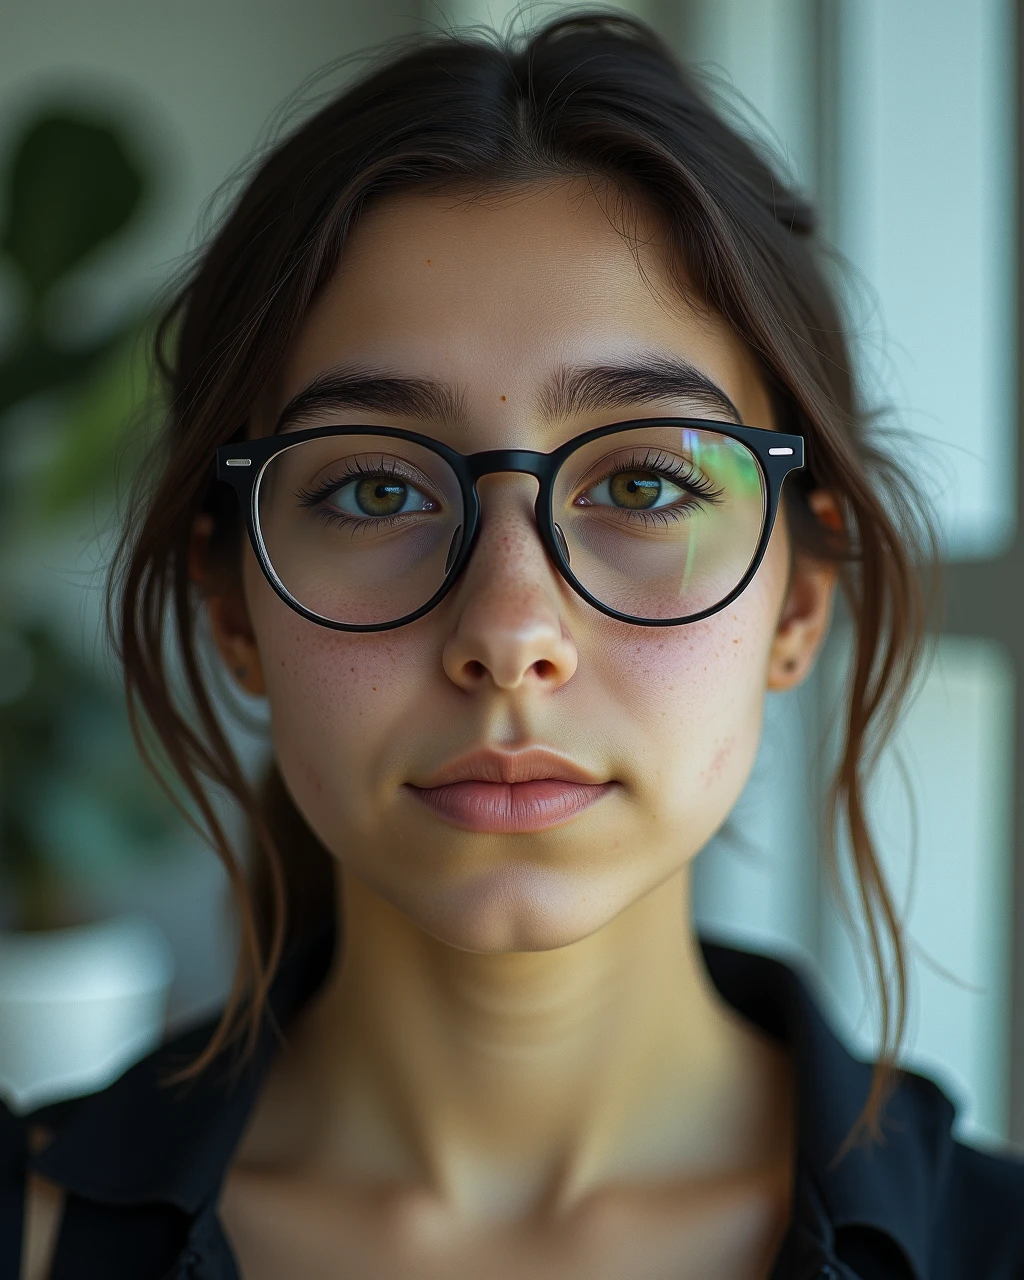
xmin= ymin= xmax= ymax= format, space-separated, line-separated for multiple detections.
xmin=768 ymin=490 xmax=842 ymax=690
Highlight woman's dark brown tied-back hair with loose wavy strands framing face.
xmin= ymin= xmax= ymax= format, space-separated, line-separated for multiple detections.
xmin=109 ymin=13 xmax=933 ymax=1152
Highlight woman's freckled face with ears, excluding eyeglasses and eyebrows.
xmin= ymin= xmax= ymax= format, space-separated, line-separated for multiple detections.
xmin=212 ymin=182 xmax=828 ymax=951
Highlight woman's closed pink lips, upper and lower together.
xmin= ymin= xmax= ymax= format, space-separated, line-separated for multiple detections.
xmin=408 ymin=749 xmax=616 ymax=835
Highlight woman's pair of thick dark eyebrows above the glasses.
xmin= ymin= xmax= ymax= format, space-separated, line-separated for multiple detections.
xmin=274 ymin=353 xmax=742 ymax=435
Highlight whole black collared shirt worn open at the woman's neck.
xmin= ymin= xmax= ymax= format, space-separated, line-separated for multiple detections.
xmin=0 ymin=928 xmax=1024 ymax=1280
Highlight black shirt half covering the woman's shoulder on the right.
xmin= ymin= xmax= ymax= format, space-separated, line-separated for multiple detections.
xmin=701 ymin=938 xmax=1024 ymax=1280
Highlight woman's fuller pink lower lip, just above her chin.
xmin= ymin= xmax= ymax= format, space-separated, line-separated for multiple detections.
xmin=410 ymin=778 xmax=614 ymax=835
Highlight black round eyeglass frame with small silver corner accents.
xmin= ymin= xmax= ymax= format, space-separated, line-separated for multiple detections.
xmin=216 ymin=417 xmax=804 ymax=631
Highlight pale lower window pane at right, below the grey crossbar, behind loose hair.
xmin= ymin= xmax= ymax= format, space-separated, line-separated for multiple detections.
xmin=820 ymin=636 xmax=1015 ymax=1142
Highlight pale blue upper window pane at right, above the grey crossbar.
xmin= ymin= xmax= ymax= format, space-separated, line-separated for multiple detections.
xmin=831 ymin=0 xmax=1016 ymax=559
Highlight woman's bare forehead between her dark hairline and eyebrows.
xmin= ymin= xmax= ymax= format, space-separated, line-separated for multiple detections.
xmin=273 ymin=179 xmax=771 ymax=447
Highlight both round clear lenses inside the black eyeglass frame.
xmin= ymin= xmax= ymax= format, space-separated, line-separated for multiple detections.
xmin=257 ymin=425 xmax=768 ymax=626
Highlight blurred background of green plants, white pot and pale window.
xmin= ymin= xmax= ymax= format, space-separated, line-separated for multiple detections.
xmin=0 ymin=0 xmax=1024 ymax=1149
